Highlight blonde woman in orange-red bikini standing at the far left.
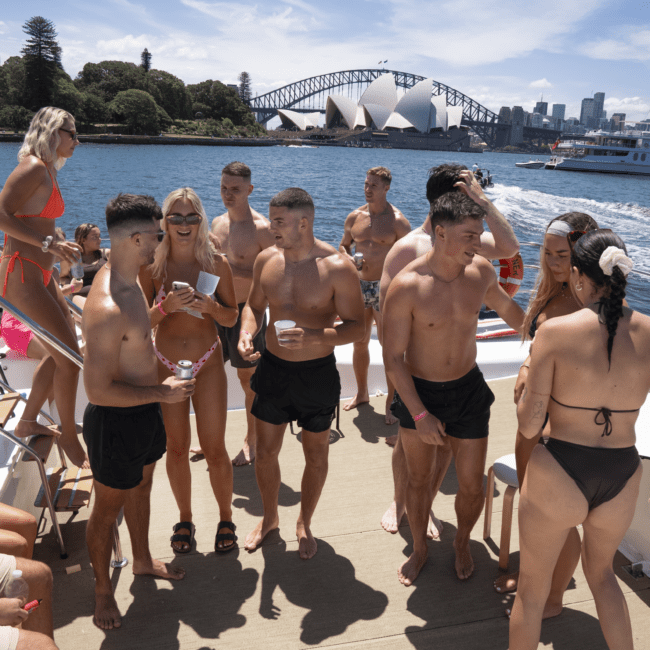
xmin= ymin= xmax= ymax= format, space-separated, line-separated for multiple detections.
xmin=0 ymin=106 xmax=89 ymax=467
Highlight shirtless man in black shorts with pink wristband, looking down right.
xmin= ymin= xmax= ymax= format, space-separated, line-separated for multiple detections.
xmin=384 ymin=192 xmax=524 ymax=585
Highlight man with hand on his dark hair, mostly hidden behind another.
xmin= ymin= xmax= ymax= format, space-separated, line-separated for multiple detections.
xmin=379 ymin=164 xmax=519 ymax=539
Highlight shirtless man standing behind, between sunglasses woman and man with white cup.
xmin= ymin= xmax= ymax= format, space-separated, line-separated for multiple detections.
xmin=212 ymin=162 xmax=275 ymax=466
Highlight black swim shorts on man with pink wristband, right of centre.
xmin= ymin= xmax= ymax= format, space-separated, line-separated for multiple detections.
xmin=390 ymin=366 xmax=494 ymax=439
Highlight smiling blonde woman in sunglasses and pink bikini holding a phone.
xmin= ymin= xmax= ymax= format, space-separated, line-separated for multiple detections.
xmin=140 ymin=187 xmax=238 ymax=553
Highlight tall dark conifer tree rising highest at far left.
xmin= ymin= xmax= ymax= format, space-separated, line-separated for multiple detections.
xmin=22 ymin=16 xmax=61 ymax=110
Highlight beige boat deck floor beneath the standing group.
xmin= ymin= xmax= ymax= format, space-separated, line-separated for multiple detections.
xmin=34 ymin=379 xmax=650 ymax=650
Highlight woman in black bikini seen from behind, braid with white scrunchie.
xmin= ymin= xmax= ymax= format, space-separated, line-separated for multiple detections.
xmin=510 ymin=230 xmax=650 ymax=650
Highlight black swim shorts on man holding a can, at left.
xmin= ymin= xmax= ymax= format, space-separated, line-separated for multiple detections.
xmin=83 ymin=402 xmax=167 ymax=490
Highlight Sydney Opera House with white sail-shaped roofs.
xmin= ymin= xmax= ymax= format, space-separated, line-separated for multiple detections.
xmin=278 ymin=73 xmax=463 ymax=134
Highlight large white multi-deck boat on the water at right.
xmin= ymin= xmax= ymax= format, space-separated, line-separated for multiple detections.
xmin=547 ymin=131 xmax=650 ymax=176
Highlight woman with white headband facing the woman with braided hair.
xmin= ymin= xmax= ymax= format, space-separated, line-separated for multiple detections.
xmin=494 ymin=212 xmax=598 ymax=618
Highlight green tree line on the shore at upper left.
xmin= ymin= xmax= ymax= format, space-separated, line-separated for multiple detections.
xmin=0 ymin=16 xmax=266 ymax=136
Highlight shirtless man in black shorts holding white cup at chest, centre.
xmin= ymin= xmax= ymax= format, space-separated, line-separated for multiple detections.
xmin=239 ymin=187 xmax=363 ymax=560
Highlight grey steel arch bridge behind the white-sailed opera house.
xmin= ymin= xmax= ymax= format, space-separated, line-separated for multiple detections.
xmin=248 ymin=69 xmax=560 ymax=148
